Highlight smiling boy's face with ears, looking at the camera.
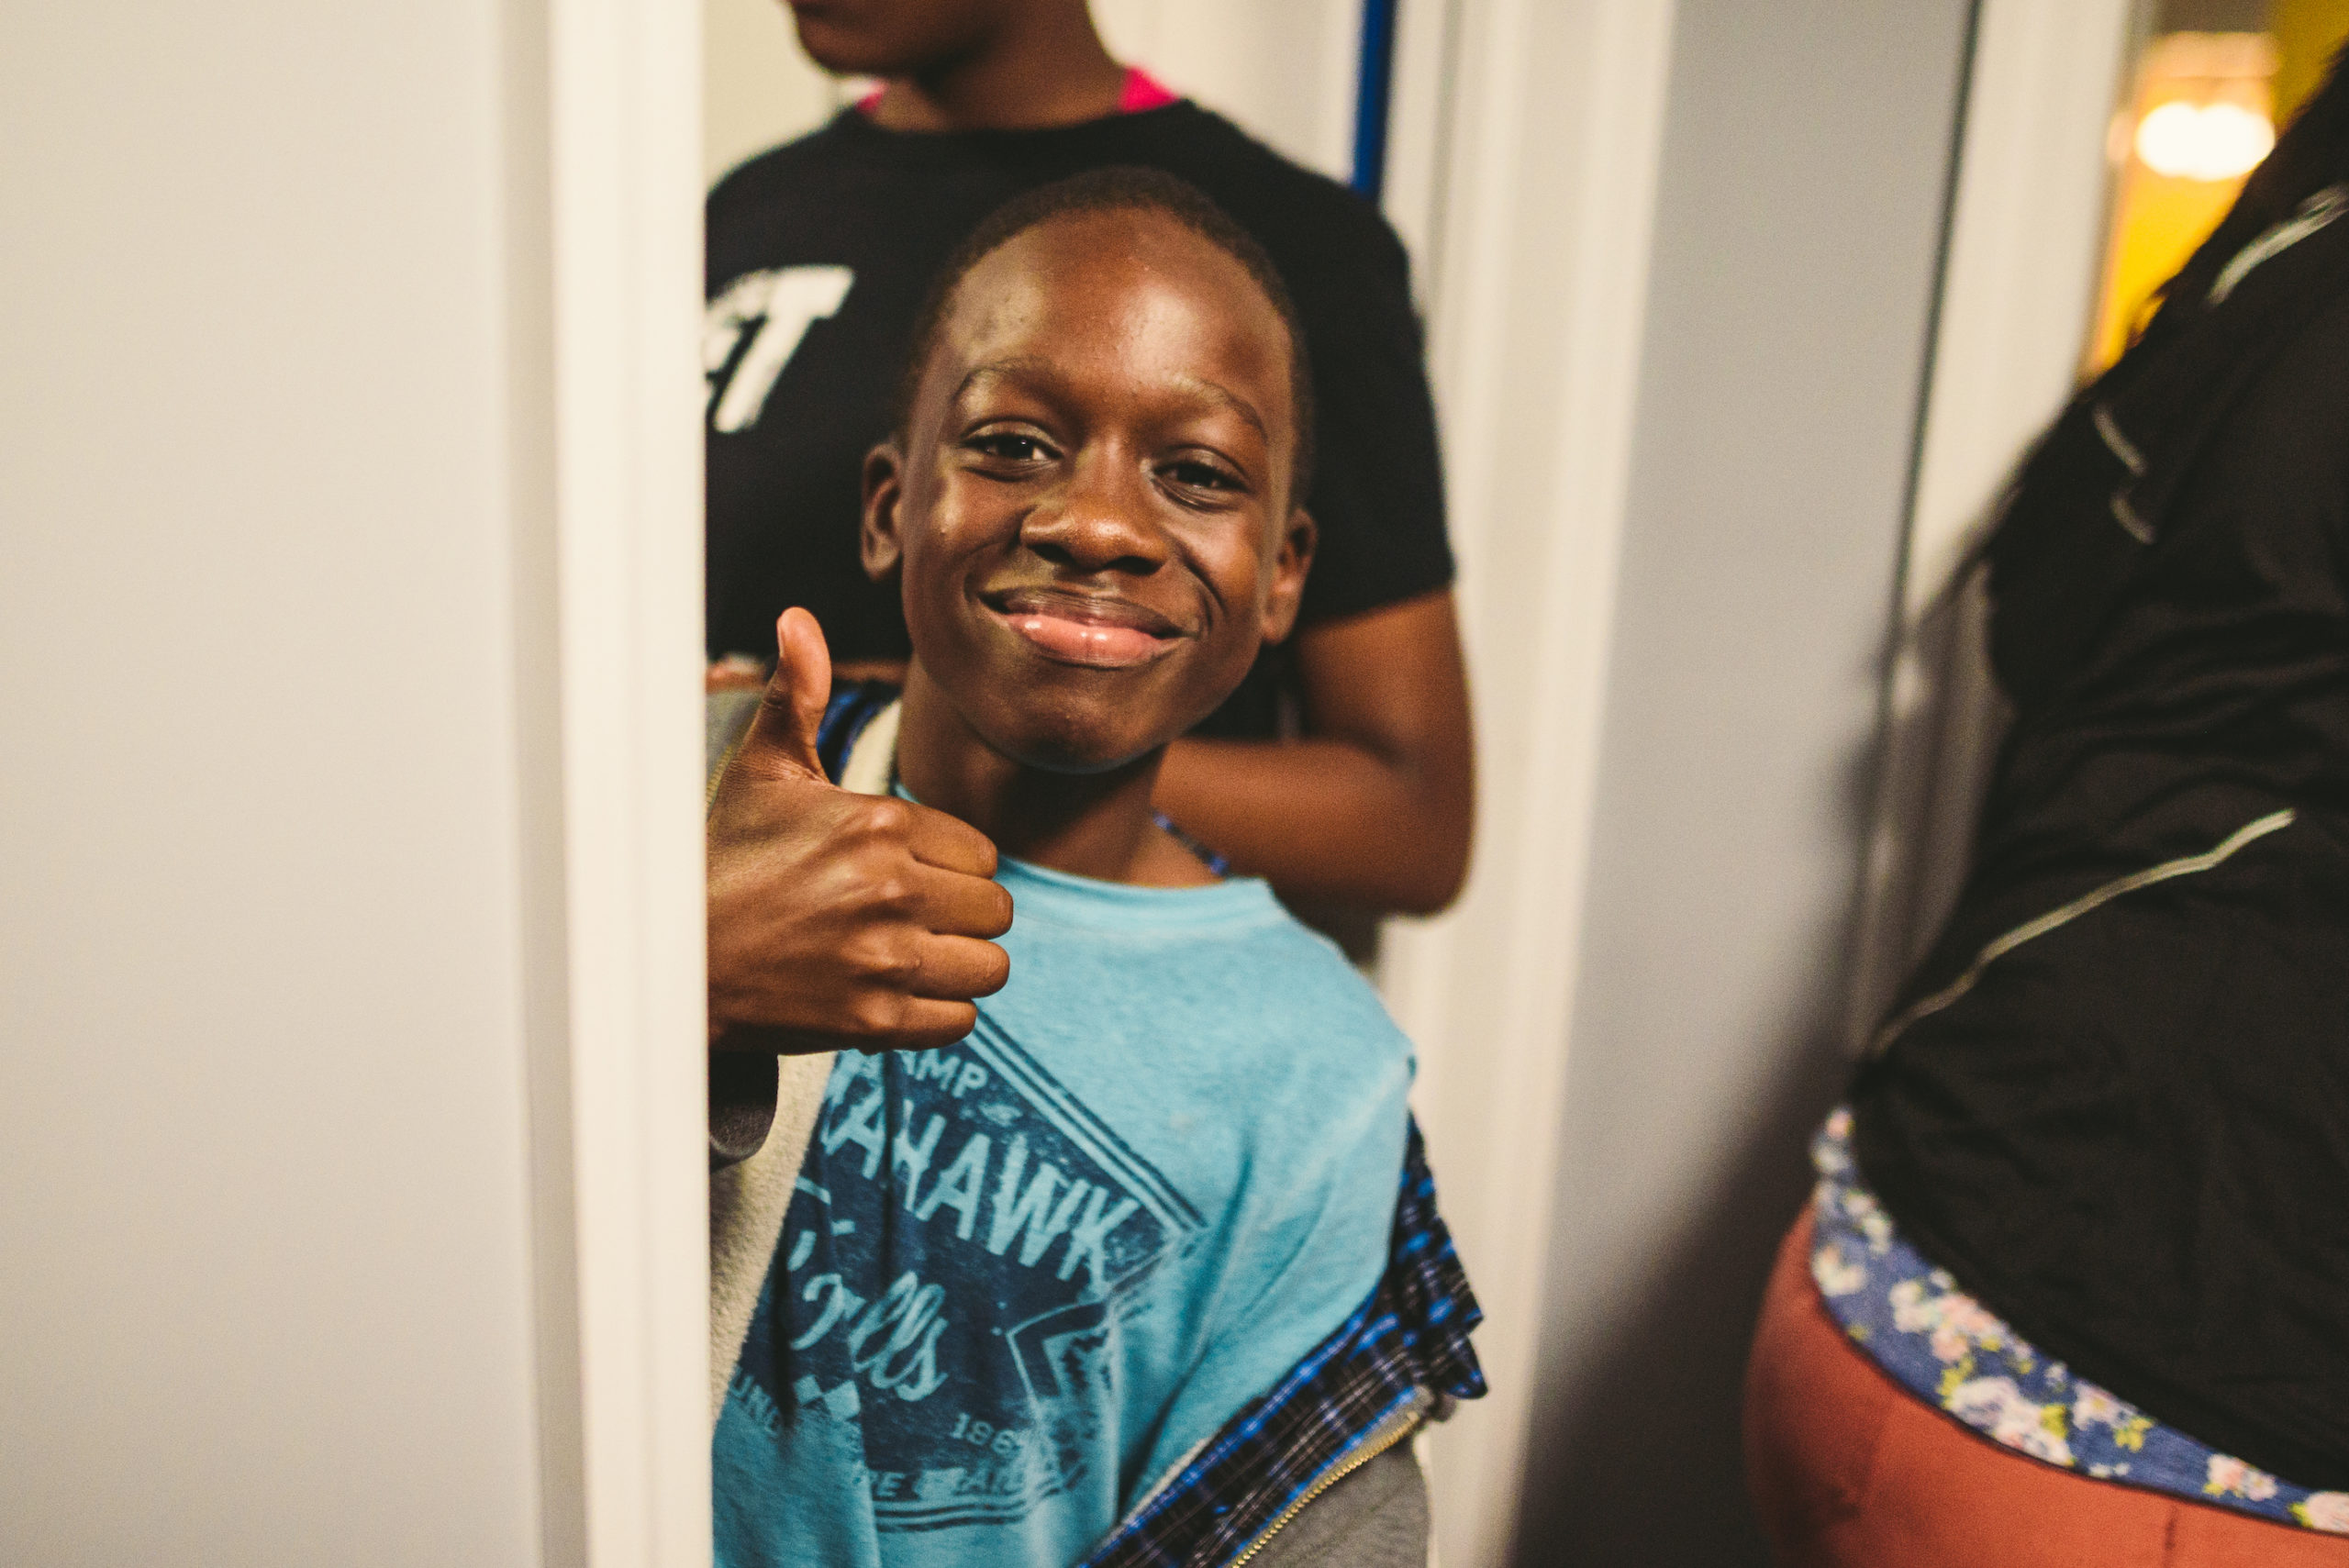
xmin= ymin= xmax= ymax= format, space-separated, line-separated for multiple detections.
xmin=864 ymin=211 xmax=1313 ymax=773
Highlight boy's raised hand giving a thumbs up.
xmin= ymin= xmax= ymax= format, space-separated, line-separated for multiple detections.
xmin=707 ymin=610 xmax=1012 ymax=1054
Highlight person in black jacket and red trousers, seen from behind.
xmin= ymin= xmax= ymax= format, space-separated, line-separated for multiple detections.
xmin=1748 ymin=49 xmax=2349 ymax=1563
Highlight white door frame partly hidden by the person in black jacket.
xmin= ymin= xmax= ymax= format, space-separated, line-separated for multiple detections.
xmin=1846 ymin=0 xmax=2140 ymax=1051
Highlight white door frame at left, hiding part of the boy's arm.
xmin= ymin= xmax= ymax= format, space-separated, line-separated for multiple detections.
xmin=535 ymin=0 xmax=709 ymax=1568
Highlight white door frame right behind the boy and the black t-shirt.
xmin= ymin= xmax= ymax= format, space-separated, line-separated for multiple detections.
xmin=1381 ymin=0 xmax=1673 ymax=1568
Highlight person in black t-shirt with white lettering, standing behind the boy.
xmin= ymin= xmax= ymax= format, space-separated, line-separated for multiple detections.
xmin=705 ymin=0 xmax=1471 ymax=911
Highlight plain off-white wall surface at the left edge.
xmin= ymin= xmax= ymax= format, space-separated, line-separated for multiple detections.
xmin=0 ymin=0 xmax=552 ymax=1568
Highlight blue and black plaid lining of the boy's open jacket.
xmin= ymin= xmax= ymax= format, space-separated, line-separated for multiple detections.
xmin=1083 ymin=1122 xmax=1485 ymax=1568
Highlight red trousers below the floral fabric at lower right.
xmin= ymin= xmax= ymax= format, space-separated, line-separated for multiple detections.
xmin=1745 ymin=1209 xmax=2349 ymax=1568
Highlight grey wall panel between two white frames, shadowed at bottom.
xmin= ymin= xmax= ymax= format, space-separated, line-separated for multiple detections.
xmin=1503 ymin=0 xmax=1971 ymax=1568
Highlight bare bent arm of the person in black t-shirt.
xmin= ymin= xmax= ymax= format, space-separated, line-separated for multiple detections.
xmin=1158 ymin=589 xmax=1475 ymax=916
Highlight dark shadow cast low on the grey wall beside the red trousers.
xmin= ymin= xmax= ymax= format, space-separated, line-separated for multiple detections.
xmin=1515 ymin=747 xmax=1876 ymax=1568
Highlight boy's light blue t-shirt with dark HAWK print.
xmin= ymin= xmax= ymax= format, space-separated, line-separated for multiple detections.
xmin=712 ymin=862 xmax=1412 ymax=1568
